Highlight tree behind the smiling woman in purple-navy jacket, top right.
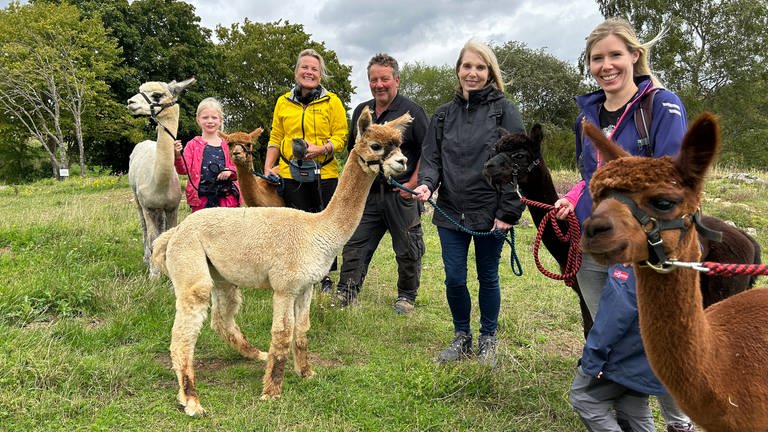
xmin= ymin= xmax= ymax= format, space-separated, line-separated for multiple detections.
xmin=597 ymin=0 xmax=768 ymax=166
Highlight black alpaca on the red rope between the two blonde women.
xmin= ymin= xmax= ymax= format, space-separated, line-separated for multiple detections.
xmin=483 ymin=124 xmax=592 ymax=338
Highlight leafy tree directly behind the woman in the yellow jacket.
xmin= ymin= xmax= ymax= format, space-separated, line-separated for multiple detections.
xmin=216 ymin=18 xmax=352 ymax=150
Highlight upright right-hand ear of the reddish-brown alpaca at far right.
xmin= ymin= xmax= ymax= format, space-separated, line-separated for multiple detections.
xmin=674 ymin=112 xmax=720 ymax=188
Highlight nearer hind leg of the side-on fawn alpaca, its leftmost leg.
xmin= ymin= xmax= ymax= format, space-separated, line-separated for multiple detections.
xmin=171 ymin=285 xmax=210 ymax=417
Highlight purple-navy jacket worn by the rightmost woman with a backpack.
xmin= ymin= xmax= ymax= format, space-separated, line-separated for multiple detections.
xmin=575 ymin=76 xmax=688 ymax=222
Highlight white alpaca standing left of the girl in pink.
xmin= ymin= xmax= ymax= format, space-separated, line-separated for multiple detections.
xmin=128 ymin=78 xmax=195 ymax=279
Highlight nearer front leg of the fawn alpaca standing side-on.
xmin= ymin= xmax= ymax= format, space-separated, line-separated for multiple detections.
xmin=261 ymin=288 xmax=296 ymax=400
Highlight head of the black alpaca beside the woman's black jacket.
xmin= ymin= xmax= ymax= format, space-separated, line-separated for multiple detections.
xmin=483 ymin=123 xmax=544 ymax=184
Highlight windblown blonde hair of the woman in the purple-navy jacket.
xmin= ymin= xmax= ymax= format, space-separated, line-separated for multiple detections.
xmin=584 ymin=17 xmax=666 ymax=87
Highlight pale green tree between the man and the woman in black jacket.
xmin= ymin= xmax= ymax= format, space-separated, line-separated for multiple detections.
xmin=399 ymin=62 xmax=456 ymax=117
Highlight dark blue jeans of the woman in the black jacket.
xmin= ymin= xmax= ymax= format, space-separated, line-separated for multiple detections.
xmin=437 ymin=227 xmax=504 ymax=335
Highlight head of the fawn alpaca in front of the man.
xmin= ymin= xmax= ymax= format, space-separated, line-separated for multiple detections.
xmin=350 ymin=106 xmax=413 ymax=178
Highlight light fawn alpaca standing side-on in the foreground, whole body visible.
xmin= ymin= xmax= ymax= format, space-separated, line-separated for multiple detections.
xmin=152 ymin=108 xmax=412 ymax=416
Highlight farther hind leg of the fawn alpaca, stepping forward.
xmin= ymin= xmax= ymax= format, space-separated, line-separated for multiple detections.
xmin=211 ymin=281 xmax=267 ymax=360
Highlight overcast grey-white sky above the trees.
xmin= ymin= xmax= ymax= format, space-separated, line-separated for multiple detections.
xmin=0 ymin=0 xmax=603 ymax=108
